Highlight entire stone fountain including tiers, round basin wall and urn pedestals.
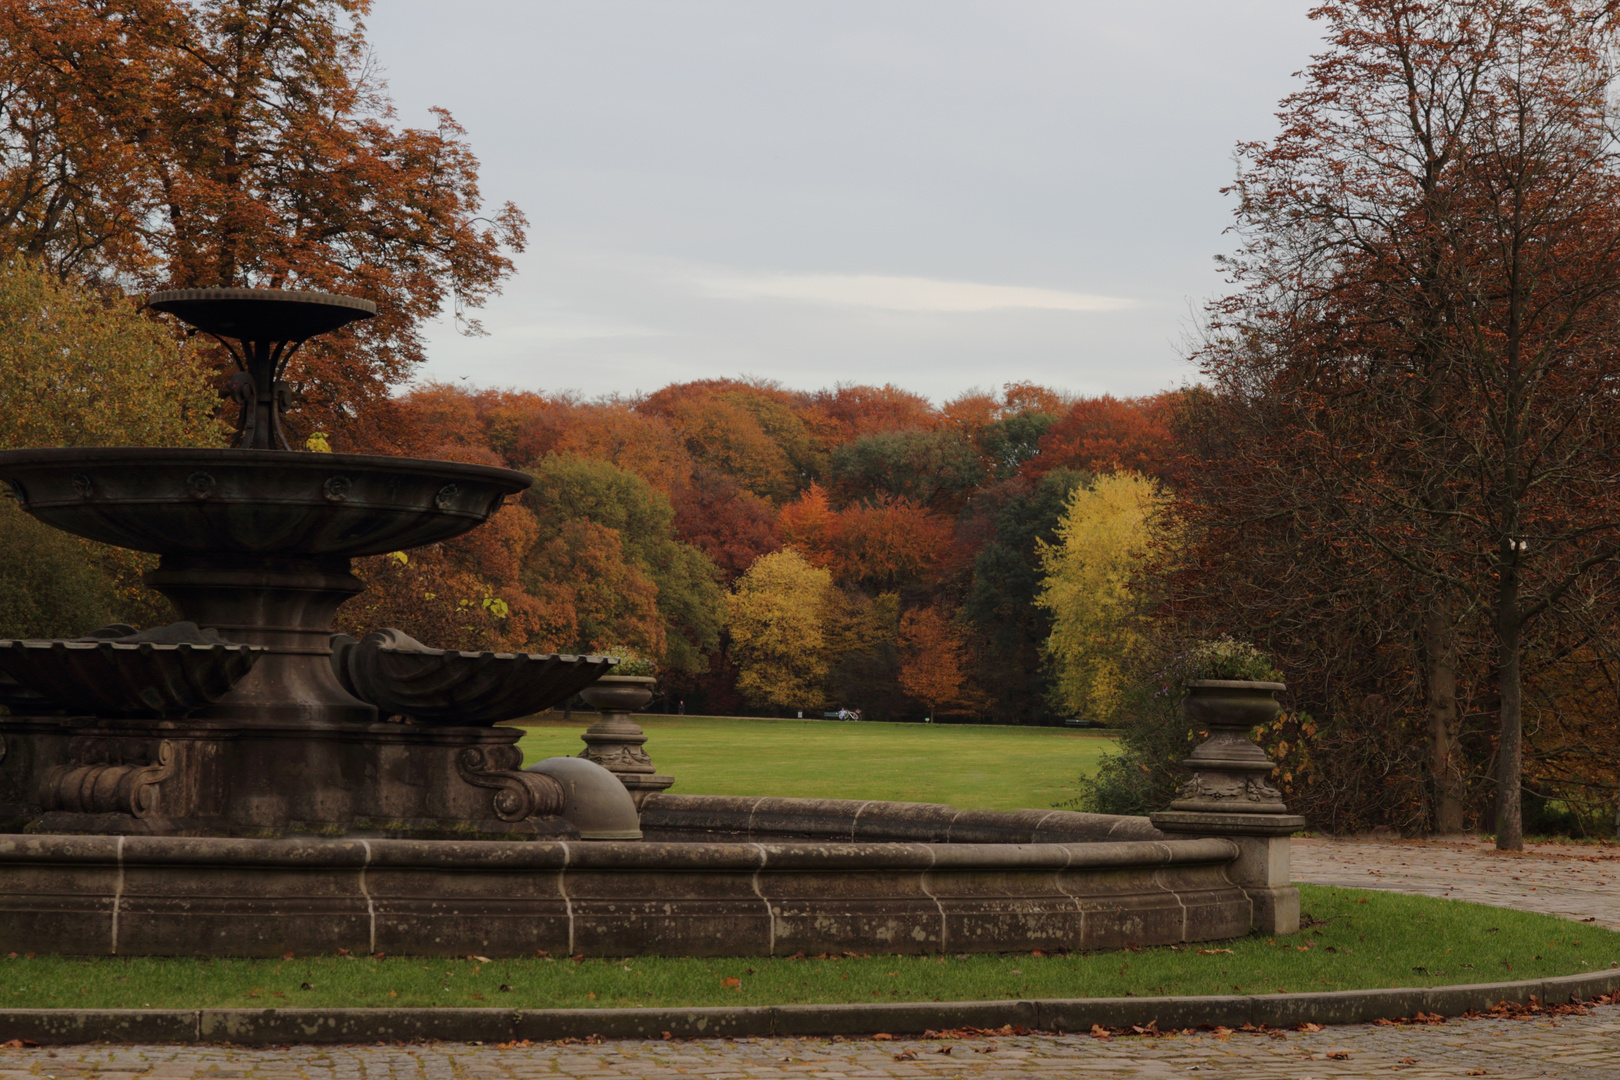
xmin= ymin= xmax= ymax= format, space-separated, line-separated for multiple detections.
xmin=0 ymin=290 xmax=1299 ymax=955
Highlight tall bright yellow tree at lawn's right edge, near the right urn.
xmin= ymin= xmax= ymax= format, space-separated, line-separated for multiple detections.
xmin=1035 ymin=471 xmax=1168 ymax=722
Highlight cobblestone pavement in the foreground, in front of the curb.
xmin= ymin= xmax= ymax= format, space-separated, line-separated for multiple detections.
xmin=0 ymin=1006 xmax=1620 ymax=1080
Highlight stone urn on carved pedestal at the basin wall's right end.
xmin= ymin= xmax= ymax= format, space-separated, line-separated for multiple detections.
xmin=1150 ymin=678 xmax=1306 ymax=934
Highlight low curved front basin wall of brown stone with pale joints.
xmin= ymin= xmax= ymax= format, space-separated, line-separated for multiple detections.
xmin=0 ymin=822 xmax=1254 ymax=957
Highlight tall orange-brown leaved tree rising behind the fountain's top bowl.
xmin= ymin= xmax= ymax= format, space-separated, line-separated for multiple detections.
xmin=0 ymin=0 xmax=525 ymax=440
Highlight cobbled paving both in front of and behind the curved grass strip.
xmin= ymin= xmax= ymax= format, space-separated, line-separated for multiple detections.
xmin=0 ymin=839 xmax=1620 ymax=1080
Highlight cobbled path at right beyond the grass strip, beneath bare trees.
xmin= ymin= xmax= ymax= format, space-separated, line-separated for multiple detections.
xmin=1291 ymin=839 xmax=1620 ymax=932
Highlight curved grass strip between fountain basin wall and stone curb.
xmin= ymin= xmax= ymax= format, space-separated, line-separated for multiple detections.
xmin=0 ymin=886 xmax=1620 ymax=1009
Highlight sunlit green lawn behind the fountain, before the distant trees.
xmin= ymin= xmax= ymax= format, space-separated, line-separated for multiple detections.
xmin=518 ymin=714 xmax=1113 ymax=810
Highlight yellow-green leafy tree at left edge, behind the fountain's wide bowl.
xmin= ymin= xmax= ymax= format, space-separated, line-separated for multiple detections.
xmin=0 ymin=256 xmax=225 ymax=636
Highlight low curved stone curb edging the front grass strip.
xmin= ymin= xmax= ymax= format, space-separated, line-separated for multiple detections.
xmin=0 ymin=970 xmax=1620 ymax=1046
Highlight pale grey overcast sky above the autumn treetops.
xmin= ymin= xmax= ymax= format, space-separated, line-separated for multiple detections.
xmin=368 ymin=0 xmax=1320 ymax=400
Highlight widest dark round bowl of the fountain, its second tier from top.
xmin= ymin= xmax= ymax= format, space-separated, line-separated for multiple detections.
xmin=0 ymin=447 xmax=533 ymax=557
